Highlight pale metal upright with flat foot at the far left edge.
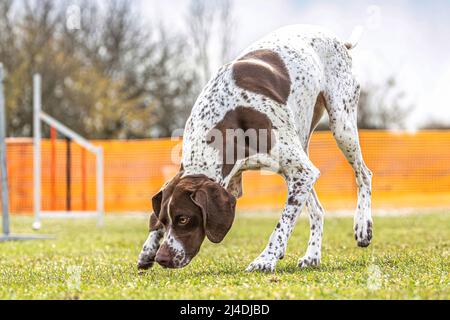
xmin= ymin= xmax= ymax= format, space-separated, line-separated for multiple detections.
xmin=0 ymin=63 xmax=53 ymax=242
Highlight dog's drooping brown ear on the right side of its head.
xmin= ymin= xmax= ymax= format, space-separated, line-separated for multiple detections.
xmin=192 ymin=181 xmax=236 ymax=243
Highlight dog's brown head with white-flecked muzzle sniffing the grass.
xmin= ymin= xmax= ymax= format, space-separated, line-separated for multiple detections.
xmin=150 ymin=174 xmax=236 ymax=268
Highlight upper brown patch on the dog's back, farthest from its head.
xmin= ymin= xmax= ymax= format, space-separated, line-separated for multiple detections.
xmin=233 ymin=49 xmax=291 ymax=104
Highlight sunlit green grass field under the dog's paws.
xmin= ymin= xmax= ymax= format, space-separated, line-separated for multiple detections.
xmin=0 ymin=212 xmax=450 ymax=299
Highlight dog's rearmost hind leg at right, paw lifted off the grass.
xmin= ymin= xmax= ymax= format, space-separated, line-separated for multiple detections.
xmin=325 ymin=72 xmax=373 ymax=247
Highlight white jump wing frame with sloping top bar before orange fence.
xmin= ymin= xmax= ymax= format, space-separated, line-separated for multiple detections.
xmin=33 ymin=74 xmax=105 ymax=229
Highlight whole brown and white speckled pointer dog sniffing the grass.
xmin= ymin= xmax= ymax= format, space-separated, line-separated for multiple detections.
xmin=138 ymin=25 xmax=372 ymax=272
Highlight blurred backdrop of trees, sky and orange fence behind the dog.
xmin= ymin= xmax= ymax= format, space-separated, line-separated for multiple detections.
xmin=0 ymin=0 xmax=450 ymax=213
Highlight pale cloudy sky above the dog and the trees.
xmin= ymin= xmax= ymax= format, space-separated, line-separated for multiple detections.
xmin=139 ymin=0 xmax=450 ymax=127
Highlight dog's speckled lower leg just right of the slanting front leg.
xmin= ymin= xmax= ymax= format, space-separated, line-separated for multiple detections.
xmin=298 ymin=190 xmax=325 ymax=268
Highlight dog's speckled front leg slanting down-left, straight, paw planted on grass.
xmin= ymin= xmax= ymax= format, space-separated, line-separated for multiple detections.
xmin=247 ymin=148 xmax=320 ymax=272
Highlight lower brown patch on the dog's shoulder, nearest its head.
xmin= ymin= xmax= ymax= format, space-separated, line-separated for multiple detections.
xmin=207 ymin=107 xmax=276 ymax=178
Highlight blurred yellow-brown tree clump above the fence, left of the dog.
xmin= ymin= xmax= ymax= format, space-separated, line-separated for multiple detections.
xmin=0 ymin=0 xmax=197 ymax=138
